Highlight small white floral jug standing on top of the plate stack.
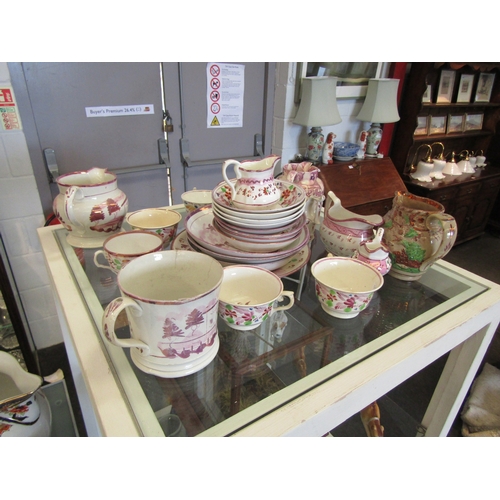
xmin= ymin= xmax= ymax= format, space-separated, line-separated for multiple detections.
xmin=222 ymin=155 xmax=281 ymax=210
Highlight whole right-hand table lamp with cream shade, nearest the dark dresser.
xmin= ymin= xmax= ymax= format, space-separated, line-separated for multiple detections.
xmin=357 ymin=78 xmax=399 ymax=158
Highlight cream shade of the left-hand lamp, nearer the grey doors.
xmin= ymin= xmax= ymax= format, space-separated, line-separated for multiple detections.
xmin=293 ymin=76 xmax=342 ymax=127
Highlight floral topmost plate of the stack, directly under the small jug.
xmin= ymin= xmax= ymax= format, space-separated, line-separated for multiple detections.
xmin=212 ymin=179 xmax=306 ymax=214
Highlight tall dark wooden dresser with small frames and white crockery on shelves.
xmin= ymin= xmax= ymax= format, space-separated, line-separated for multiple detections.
xmin=390 ymin=62 xmax=500 ymax=243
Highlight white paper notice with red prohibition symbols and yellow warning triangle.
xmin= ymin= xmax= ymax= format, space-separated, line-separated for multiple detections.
xmin=207 ymin=63 xmax=245 ymax=128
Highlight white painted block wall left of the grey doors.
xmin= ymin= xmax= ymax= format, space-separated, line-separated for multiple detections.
xmin=0 ymin=62 xmax=62 ymax=349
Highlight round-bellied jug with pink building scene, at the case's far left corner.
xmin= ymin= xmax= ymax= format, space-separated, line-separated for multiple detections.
xmin=53 ymin=168 xmax=128 ymax=248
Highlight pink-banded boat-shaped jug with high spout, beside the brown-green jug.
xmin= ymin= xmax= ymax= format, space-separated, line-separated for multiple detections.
xmin=319 ymin=191 xmax=384 ymax=257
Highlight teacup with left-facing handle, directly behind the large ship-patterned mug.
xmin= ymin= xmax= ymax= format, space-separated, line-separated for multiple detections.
xmin=94 ymin=230 xmax=163 ymax=274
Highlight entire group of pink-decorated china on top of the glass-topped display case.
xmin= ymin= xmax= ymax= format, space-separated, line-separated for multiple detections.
xmin=54 ymin=156 xmax=456 ymax=378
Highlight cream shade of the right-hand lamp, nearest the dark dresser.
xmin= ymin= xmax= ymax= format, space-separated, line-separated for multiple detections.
xmin=357 ymin=78 xmax=399 ymax=123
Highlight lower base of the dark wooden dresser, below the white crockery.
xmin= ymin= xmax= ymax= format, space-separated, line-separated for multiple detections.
xmin=405 ymin=165 xmax=500 ymax=243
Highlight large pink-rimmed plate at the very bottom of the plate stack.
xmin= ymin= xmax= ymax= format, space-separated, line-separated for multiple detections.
xmin=186 ymin=207 xmax=309 ymax=260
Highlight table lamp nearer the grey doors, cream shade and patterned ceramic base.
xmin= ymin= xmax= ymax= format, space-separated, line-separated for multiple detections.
xmin=293 ymin=76 xmax=342 ymax=163
